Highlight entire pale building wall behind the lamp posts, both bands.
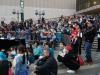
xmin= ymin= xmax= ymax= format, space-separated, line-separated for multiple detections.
xmin=0 ymin=0 xmax=76 ymax=23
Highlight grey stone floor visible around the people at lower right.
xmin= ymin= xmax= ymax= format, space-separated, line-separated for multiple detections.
xmin=30 ymin=51 xmax=100 ymax=75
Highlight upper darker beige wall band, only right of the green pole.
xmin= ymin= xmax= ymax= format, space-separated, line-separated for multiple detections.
xmin=24 ymin=0 xmax=76 ymax=9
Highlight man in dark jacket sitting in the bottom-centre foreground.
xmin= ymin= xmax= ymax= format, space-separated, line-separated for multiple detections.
xmin=35 ymin=49 xmax=58 ymax=75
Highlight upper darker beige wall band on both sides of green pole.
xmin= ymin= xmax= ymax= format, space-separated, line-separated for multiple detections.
xmin=0 ymin=0 xmax=76 ymax=9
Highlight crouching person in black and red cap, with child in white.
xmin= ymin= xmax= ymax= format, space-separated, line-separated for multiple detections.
xmin=57 ymin=42 xmax=80 ymax=73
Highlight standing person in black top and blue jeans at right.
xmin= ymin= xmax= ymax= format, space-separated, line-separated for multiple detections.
xmin=84 ymin=20 xmax=96 ymax=64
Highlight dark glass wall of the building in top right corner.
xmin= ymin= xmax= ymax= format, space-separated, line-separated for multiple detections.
xmin=76 ymin=0 xmax=100 ymax=11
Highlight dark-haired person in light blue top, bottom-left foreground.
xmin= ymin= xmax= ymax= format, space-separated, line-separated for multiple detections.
xmin=13 ymin=45 xmax=28 ymax=75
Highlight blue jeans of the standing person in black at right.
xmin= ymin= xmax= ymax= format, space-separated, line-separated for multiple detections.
xmin=85 ymin=42 xmax=92 ymax=62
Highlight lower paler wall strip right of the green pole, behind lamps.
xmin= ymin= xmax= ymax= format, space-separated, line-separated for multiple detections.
xmin=25 ymin=7 xmax=75 ymax=19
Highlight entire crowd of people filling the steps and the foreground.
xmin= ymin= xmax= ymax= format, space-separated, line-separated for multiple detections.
xmin=0 ymin=15 xmax=100 ymax=75
